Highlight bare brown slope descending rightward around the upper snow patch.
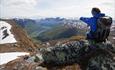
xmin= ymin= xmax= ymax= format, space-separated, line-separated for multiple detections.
xmin=0 ymin=20 xmax=37 ymax=52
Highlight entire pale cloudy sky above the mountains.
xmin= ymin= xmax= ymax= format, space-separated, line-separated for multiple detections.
xmin=0 ymin=0 xmax=115 ymax=18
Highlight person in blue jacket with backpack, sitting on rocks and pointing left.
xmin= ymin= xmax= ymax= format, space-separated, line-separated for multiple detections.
xmin=80 ymin=8 xmax=112 ymax=42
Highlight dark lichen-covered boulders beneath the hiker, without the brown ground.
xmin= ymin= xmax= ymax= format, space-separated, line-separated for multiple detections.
xmin=34 ymin=40 xmax=115 ymax=70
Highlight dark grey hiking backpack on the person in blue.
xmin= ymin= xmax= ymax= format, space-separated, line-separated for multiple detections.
xmin=94 ymin=16 xmax=112 ymax=42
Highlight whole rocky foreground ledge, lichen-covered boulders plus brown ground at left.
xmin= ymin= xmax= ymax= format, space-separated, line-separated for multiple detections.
xmin=2 ymin=37 xmax=115 ymax=70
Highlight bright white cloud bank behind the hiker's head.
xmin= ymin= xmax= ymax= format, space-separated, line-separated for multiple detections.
xmin=35 ymin=0 xmax=115 ymax=18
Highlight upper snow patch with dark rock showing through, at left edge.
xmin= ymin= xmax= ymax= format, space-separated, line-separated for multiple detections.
xmin=0 ymin=21 xmax=17 ymax=44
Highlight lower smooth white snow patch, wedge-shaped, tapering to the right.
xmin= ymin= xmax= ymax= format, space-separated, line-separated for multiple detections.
xmin=0 ymin=52 xmax=29 ymax=65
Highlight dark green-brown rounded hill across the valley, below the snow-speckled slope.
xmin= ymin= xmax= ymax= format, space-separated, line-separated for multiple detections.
xmin=36 ymin=25 xmax=86 ymax=41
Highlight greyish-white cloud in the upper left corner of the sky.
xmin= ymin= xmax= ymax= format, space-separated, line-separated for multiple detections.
xmin=0 ymin=0 xmax=37 ymax=17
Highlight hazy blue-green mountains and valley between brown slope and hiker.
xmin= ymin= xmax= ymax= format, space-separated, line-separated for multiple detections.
xmin=14 ymin=17 xmax=87 ymax=41
